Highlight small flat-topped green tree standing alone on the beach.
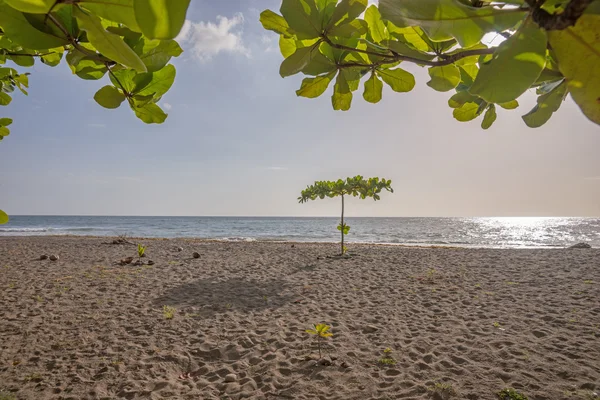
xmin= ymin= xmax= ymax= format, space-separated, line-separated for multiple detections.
xmin=298 ymin=175 xmax=394 ymax=255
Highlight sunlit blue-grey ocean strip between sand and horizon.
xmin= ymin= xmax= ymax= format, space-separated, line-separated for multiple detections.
xmin=0 ymin=215 xmax=600 ymax=248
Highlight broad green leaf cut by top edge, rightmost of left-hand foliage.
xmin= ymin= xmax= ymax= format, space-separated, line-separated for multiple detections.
xmin=133 ymin=0 xmax=190 ymax=39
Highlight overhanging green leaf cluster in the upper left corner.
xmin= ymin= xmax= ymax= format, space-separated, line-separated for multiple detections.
xmin=0 ymin=0 xmax=189 ymax=134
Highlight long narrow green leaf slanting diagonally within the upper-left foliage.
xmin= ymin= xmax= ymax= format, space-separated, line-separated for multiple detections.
xmin=73 ymin=7 xmax=147 ymax=72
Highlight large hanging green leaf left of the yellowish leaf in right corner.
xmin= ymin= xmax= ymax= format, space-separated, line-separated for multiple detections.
xmin=469 ymin=20 xmax=548 ymax=103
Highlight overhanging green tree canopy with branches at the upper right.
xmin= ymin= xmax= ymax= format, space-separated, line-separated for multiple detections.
xmin=260 ymin=0 xmax=600 ymax=129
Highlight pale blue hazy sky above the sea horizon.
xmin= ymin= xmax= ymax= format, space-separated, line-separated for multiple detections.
xmin=0 ymin=0 xmax=600 ymax=216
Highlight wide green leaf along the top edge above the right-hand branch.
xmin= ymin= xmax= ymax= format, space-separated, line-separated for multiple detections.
xmin=379 ymin=0 xmax=527 ymax=47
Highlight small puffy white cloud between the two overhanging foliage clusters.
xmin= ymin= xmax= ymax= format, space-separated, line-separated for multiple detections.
xmin=176 ymin=13 xmax=250 ymax=62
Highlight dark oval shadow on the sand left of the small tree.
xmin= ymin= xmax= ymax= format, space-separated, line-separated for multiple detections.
xmin=154 ymin=278 xmax=292 ymax=317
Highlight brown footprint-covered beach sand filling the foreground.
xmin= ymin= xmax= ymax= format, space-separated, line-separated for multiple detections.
xmin=0 ymin=237 xmax=600 ymax=400
